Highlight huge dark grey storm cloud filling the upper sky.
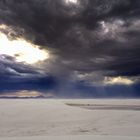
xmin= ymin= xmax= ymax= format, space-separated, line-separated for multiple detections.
xmin=0 ymin=0 xmax=140 ymax=97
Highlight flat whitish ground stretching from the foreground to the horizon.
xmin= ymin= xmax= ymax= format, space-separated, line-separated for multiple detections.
xmin=0 ymin=99 xmax=140 ymax=140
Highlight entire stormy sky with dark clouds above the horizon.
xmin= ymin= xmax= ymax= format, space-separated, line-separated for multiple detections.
xmin=0 ymin=0 xmax=140 ymax=98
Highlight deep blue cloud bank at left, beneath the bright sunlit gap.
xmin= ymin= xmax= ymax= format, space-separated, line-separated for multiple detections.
xmin=0 ymin=55 xmax=56 ymax=93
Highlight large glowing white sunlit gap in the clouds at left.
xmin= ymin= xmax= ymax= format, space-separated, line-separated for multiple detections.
xmin=0 ymin=25 xmax=49 ymax=64
